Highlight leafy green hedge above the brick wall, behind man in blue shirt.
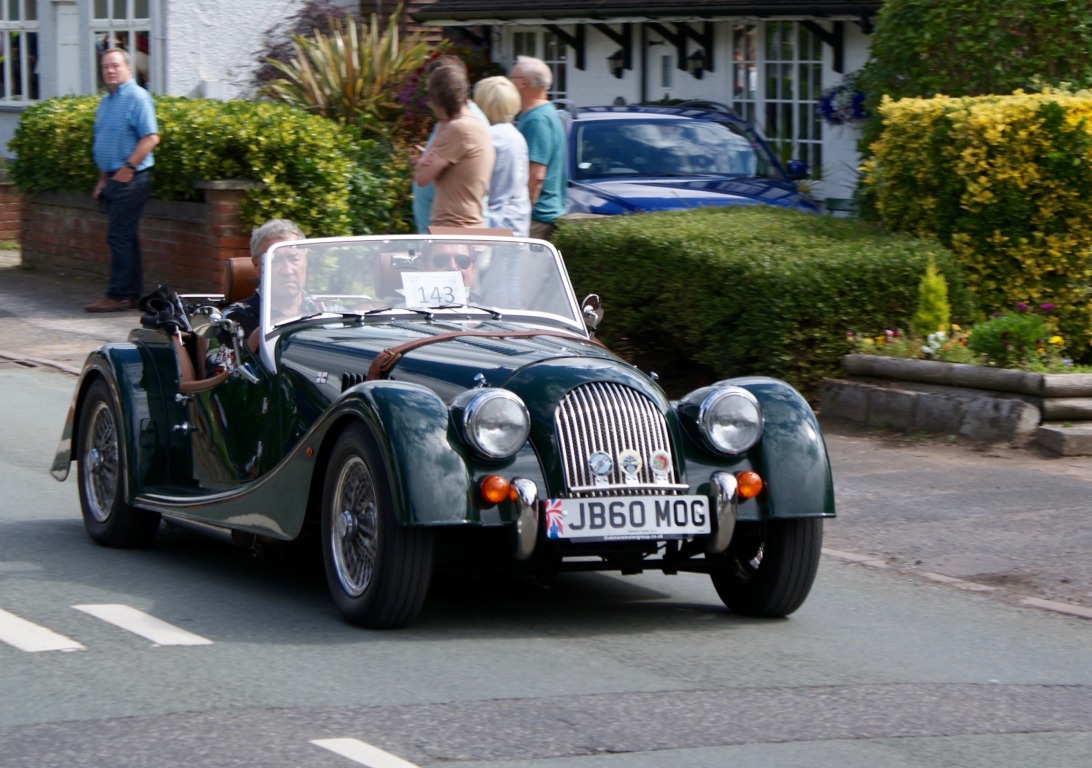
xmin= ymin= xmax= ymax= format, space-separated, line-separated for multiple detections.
xmin=9 ymin=96 xmax=410 ymax=236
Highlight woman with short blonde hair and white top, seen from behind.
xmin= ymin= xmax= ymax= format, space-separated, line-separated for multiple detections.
xmin=474 ymin=76 xmax=531 ymax=237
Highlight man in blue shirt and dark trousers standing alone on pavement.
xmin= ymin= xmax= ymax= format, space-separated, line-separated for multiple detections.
xmin=84 ymin=48 xmax=159 ymax=312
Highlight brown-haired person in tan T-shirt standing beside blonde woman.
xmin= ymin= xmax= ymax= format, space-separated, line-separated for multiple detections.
xmin=414 ymin=60 xmax=495 ymax=227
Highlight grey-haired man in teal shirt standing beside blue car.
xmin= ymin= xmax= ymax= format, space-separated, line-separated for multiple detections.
xmin=509 ymin=56 xmax=569 ymax=240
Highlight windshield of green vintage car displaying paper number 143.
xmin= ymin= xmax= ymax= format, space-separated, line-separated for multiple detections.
xmin=261 ymin=235 xmax=583 ymax=329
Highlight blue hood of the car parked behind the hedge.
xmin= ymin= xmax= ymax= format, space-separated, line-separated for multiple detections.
xmin=569 ymin=178 xmax=818 ymax=215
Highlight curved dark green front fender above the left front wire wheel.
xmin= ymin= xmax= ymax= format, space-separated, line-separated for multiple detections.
xmin=337 ymin=380 xmax=474 ymax=525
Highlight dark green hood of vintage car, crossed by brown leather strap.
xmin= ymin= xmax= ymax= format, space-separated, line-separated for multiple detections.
xmin=280 ymin=321 xmax=649 ymax=400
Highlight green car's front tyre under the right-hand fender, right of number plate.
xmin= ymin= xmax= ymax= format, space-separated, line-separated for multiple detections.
xmin=710 ymin=518 xmax=822 ymax=618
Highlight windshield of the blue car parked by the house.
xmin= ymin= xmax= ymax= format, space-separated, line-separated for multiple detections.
xmin=572 ymin=118 xmax=779 ymax=180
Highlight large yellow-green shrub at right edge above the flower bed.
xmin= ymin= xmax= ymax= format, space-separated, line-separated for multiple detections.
xmin=865 ymin=92 xmax=1092 ymax=356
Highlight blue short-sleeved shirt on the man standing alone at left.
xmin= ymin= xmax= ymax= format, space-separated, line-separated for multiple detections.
xmin=92 ymin=80 xmax=159 ymax=174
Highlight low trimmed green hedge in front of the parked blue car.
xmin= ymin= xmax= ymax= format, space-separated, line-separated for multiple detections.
xmin=554 ymin=206 xmax=975 ymax=395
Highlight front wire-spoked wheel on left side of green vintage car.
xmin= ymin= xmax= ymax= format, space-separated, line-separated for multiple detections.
xmin=322 ymin=425 xmax=432 ymax=629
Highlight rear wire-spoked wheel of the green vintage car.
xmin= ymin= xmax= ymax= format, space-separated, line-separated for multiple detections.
xmin=76 ymin=379 xmax=159 ymax=547
